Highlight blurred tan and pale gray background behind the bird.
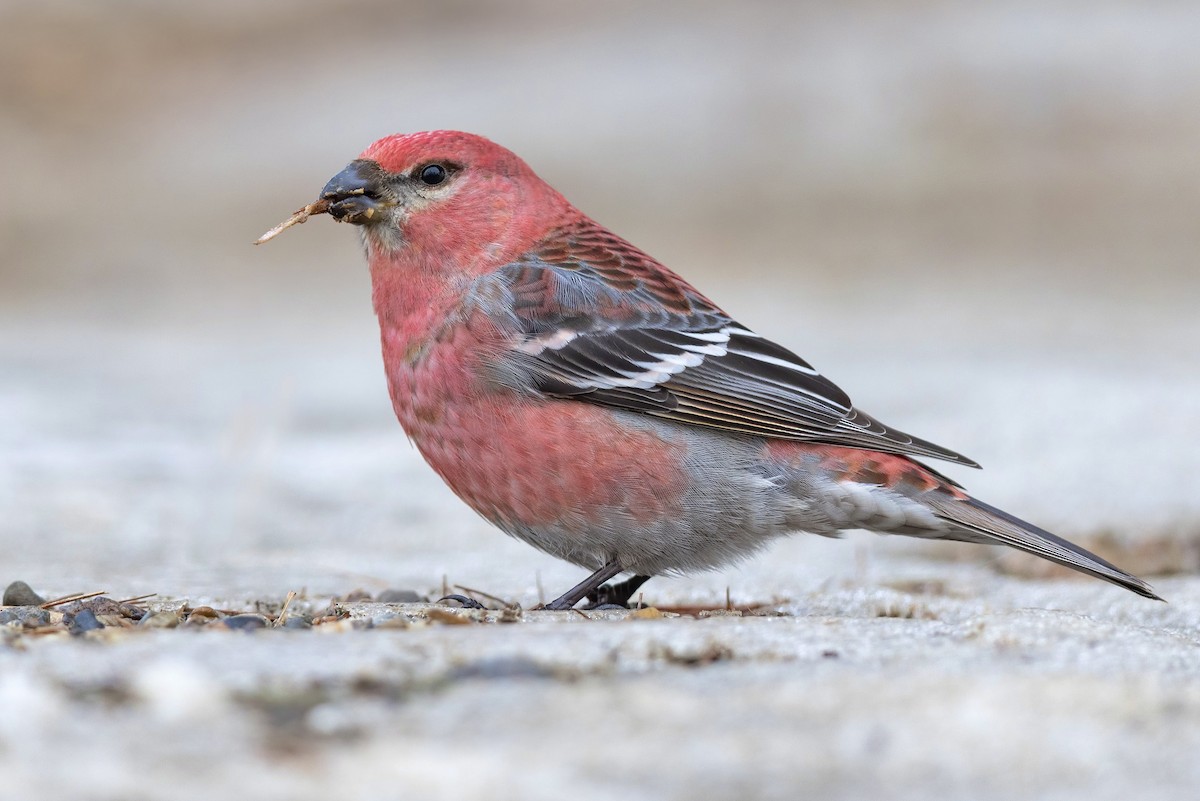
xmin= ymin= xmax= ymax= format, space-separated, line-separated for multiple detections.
xmin=0 ymin=0 xmax=1200 ymax=601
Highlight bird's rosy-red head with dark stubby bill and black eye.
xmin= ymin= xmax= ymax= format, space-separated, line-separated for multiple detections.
xmin=322 ymin=131 xmax=570 ymax=271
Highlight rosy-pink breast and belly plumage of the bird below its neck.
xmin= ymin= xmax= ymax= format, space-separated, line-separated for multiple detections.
xmin=384 ymin=318 xmax=686 ymax=534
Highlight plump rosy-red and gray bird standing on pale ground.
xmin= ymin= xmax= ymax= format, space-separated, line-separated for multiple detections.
xmin=288 ymin=131 xmax=1158 ymax=609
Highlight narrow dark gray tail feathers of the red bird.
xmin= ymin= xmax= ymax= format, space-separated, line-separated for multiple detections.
xmin=924 ymin=493 xmax=1163 ymax=601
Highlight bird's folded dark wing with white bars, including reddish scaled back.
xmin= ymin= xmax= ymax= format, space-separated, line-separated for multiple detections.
xmin=494 ymin=222 xmax=978 ymax=466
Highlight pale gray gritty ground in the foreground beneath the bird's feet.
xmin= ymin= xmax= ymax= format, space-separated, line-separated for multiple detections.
xmin=0 ymin=570 xmax=1200 ymax=799
